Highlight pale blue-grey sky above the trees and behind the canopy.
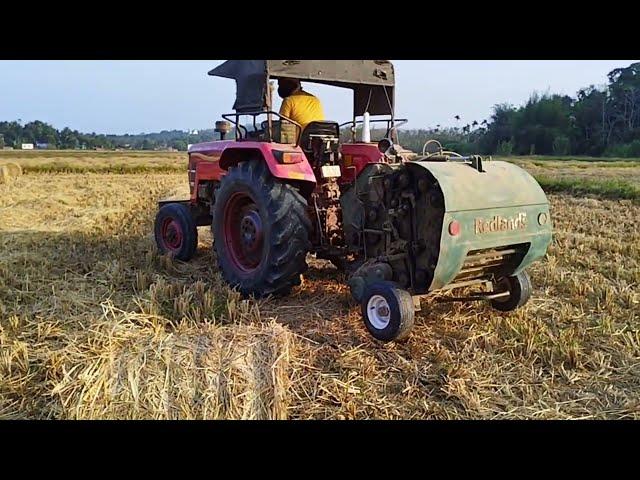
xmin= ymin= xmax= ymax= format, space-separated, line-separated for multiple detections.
xmin=0 ymin=60 xmax=637 ymax=134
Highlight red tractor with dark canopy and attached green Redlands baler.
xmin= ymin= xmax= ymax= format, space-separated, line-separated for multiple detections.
xmin=155 ymin=60 xmax=551 ymax=341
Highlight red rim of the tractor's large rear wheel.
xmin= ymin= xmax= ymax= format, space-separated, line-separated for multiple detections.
xmin=223 ymin=192 xmax=264 ymax=273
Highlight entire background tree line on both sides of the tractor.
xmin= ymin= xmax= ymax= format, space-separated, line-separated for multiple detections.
xmin=0 ymin=63 xmax=640 ymax=157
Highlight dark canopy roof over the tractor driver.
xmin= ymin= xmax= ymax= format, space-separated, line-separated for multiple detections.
xmin=209 ymin=60 xmax=395 ymax=116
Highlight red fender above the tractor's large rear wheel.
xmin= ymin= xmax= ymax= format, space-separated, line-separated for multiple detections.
xmin=220 ymin=142 xmax=316 ymax=192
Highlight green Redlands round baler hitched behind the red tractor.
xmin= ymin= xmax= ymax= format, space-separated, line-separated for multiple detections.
xmin=342 ymin=156 xmax=552 ymax=339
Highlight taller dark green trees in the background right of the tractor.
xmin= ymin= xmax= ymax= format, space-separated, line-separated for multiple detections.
xmin=400 ymin=63 xmax=640 ymax=157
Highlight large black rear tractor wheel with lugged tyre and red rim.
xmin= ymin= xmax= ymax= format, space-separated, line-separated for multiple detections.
xmin=212 ymin=160 xmax=311 ymax=297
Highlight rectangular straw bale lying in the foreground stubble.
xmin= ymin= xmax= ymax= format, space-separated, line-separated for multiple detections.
xmin=50 ymin=312 xmax=292 ymax=419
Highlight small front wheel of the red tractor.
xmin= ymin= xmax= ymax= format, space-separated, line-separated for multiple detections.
xmin=154 ymin=203 xmax=198 ymax=262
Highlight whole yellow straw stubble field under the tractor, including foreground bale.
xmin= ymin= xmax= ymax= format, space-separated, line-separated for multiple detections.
xmin=0 ymin=153 xmax=640 ymax=419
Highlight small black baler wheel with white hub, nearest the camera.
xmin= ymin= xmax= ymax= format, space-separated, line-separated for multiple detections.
xmin=361 ymin=281 xmax=415 ymax=342
